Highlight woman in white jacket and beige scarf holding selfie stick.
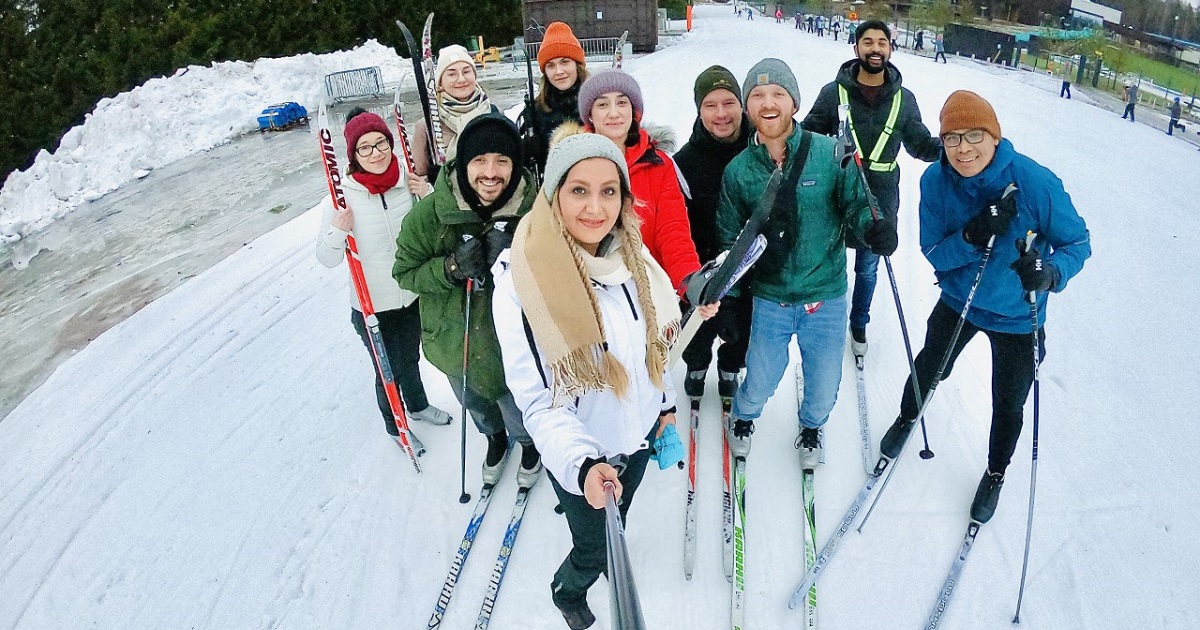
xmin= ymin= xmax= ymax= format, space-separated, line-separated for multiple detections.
xmin=492 ymin=133 xmax=715 ymax=629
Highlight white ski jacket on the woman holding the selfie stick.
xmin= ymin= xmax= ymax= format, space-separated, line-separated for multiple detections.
xmin=492 ymin=251 xmax=676 ymax=496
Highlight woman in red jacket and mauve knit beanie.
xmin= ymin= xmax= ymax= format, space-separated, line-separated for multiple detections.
xmin=564 ymin=70 xmax=700 ymax=289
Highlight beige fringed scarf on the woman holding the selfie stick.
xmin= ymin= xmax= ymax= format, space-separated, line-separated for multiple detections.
xmin=511 ymin=194 xmax=680 ymax=400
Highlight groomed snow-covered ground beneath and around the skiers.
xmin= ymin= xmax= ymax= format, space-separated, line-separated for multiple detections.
xmin=0 ymin=6 xmax=1200 ymax=630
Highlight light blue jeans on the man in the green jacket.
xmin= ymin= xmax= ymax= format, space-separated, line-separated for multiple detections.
xmin=733 ymin=295 xmax=846 ymax=428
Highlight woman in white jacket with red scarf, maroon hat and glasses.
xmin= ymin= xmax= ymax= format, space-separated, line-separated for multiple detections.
xmin=317 ymin=107 xmax=450 ymax=436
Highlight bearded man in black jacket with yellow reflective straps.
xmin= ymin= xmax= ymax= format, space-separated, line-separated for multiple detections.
xmin=800 ymin=20 xmax=942 ymax=356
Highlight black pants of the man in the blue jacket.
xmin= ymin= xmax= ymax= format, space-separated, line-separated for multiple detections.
xmin=900 ymin=300 xmax=1045 ymax=473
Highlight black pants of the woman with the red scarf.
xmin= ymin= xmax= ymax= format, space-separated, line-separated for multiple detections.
xmin=350 ymin=300 xmax=430 ymax=436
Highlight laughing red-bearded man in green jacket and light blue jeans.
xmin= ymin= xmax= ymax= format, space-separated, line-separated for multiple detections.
xmin=716 ymin=59 xmax=896 ymax=469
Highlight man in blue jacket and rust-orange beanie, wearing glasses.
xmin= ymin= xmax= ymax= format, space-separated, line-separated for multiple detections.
xmin=880 ymin=90 xmax=1092 ymax=523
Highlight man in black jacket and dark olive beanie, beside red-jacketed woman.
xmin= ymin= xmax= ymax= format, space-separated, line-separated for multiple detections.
xmin=674 ymin=66 xmax=754 ymax=398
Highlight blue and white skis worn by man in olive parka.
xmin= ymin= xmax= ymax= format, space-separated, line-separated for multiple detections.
xmin=427 ymin=453 xmax=532 ymax=630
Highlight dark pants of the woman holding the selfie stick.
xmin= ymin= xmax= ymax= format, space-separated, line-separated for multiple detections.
xmin=547 ymin=436 xmax=653 ymax=604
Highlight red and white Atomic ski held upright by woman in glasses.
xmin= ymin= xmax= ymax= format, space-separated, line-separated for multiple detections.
xmin=317 ymin=103 xmax=425 ymax=473
